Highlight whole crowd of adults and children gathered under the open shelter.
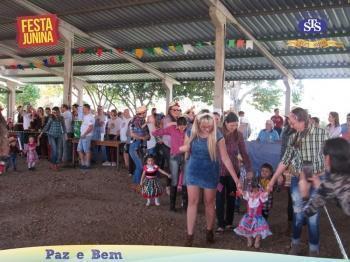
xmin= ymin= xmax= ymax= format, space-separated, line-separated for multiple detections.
xmin=3 ymin=102 xmax=350 ymax=256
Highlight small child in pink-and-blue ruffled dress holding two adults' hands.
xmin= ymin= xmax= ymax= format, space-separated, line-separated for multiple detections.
xmin=234 ymin=183 xmax=272 ymax=248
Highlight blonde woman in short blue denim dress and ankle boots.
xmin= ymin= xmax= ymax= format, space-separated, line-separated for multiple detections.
xmin=180 ymin=113 xmax=241 ymax=246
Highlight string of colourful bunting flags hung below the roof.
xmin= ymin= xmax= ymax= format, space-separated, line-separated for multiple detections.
xmin=9 ymin=39 xmax=254 ymax=70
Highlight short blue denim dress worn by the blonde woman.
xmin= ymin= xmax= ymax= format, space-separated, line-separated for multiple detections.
xmin=185 ymin=130 xmax=223 ymax=189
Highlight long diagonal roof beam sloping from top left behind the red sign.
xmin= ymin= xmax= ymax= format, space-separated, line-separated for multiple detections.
xmin=13 ymin=0 xmax=179 ymax=84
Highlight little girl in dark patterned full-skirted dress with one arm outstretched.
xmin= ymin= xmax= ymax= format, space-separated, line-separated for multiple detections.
xmin=140 ymin=155 xmax=171 ymax=206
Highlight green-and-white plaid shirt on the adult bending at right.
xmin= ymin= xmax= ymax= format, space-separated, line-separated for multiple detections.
xmin=281 ymin=126 xmax=329 ymax=175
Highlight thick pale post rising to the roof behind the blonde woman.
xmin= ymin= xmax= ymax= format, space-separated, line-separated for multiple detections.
xmin=209 ymin=6 xmax=226 ymax=113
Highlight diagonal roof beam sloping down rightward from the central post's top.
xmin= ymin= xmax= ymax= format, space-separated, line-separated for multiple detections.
xmin=208 ymin=0 xmax=294 ymax=81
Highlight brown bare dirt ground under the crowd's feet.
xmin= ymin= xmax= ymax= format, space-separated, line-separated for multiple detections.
xmin=0 ymin=160 xmax=350 ymax=258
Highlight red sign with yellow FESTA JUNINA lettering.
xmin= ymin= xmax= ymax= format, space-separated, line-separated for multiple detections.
xmin=17 ymin=15 xmax=58 ymax=47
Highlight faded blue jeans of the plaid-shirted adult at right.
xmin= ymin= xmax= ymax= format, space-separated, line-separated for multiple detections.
xmin=290 ymin=176 xmax=320 ymax=252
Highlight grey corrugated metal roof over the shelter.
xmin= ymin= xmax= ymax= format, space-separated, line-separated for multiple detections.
xmin=0 ymin=0 xmax=350 ymax=82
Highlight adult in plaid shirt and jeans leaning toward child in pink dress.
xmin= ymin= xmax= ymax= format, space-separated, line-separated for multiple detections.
xmin=268 ymin=107 xmax=329 ymax=256
